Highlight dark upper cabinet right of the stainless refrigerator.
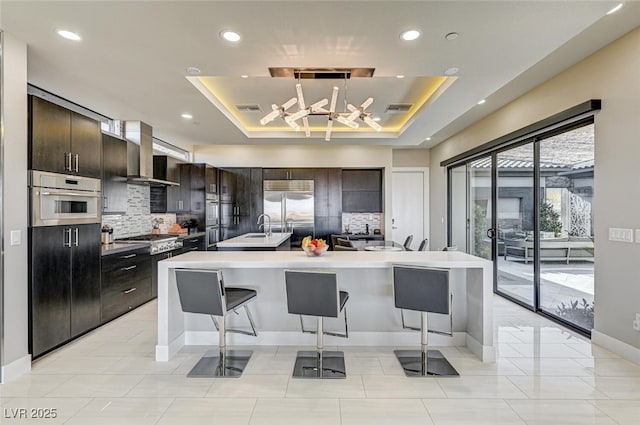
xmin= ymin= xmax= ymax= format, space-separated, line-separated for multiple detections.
xmin=342 ymin=170 xmax=383 ymax=213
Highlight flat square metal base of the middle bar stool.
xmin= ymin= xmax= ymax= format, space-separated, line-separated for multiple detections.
xmin=292 ymin=351 xmax=347 ymax=379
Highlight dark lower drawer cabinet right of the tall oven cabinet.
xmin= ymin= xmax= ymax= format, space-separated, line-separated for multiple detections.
xmin=102 ymin=248 xmax=152 ymax=322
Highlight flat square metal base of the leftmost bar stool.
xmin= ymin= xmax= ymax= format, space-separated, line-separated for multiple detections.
xmin=187 ymin=350 xmax=253 ymax=378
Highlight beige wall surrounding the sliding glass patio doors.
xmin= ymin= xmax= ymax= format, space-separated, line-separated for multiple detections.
xmin=431 ymin=29 xmax=640 ymax=362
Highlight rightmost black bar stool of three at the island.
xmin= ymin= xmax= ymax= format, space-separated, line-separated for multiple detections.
xmin=393 ymin=266 xmax=458 ymax=376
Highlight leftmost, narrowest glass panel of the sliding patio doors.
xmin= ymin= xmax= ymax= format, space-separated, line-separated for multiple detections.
xmin=449 ymin=164 xmax=469 ymax=252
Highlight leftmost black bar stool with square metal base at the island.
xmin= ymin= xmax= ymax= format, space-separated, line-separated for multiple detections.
xmin=176 ymin=269 xmax=258 ymax=378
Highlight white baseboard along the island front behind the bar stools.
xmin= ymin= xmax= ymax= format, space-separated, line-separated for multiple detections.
xmin=184 ymin=331 xmax=467 ymax=347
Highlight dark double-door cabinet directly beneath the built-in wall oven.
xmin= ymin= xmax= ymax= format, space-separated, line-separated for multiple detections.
xmin=29 ymin=224 xmax=100 ymax=357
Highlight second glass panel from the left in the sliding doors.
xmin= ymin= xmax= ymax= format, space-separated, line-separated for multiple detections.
xmin=467 ymin=157 xmax=493 ymax=260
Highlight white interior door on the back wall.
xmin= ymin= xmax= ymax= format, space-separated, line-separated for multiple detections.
xmin=391 ymin=169 xmax=429 ymax=249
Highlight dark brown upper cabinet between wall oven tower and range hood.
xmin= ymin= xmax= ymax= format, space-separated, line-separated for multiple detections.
xmin=102 ymin=134 xmax=128 ymax=214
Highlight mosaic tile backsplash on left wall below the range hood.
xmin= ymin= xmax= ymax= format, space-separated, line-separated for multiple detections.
xmin=102 ymin=184 xmax=154 ymax=239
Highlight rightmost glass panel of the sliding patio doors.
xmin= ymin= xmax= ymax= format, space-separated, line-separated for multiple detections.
xmin=540 ymin=124 xmax=594 ymax=331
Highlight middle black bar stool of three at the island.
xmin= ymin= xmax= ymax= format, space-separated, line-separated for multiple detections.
xmin=284 ymin=270 xmax=349 ymax=379
